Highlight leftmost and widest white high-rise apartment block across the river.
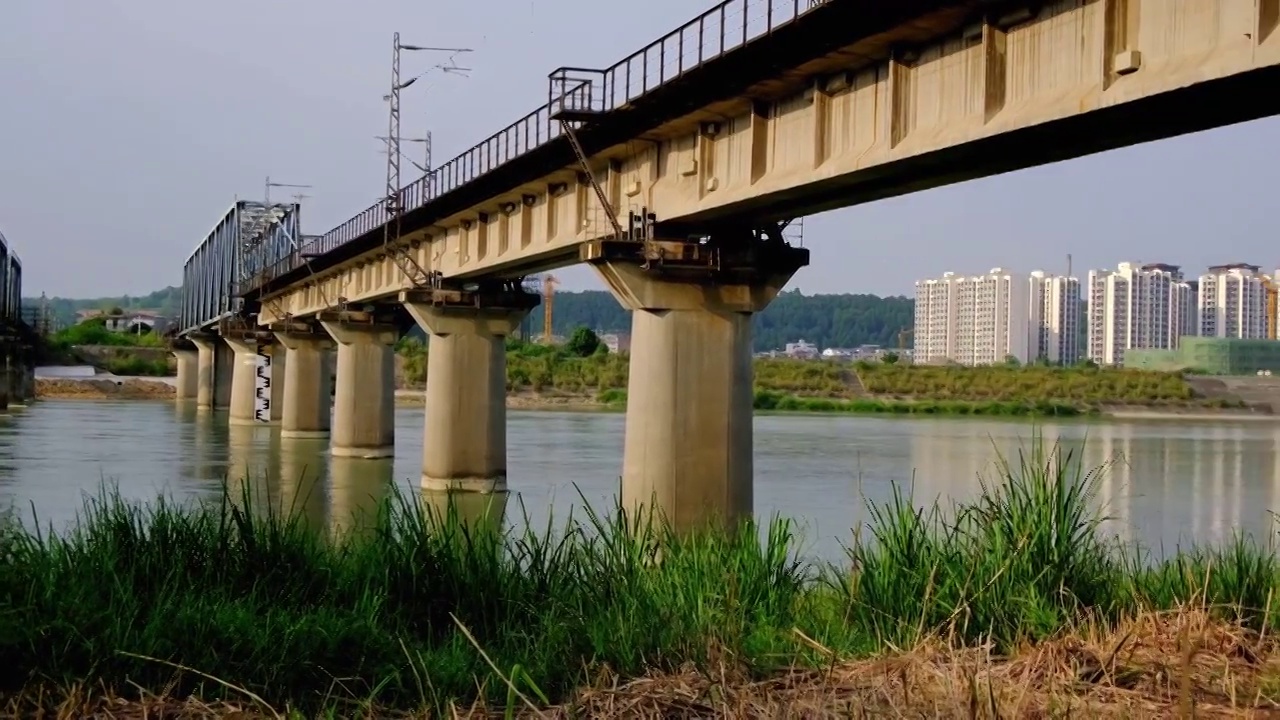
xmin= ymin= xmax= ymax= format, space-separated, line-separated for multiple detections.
xmin=914 ymin=268 xmax=1032 ymax=365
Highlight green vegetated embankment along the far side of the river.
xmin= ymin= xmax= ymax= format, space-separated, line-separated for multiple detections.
xmin=37 ymin=341 xmax=1280 ymax=419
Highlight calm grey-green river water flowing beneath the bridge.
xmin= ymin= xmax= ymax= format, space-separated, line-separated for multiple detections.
xmin=0 ymin=400 xmax=1280 ymax=559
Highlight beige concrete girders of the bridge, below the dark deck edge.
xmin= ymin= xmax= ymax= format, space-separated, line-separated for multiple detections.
xmin=259 ymin=0 xmax=1280 ymax=316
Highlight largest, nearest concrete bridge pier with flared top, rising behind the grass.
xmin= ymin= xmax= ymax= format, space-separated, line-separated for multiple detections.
xmin=582 ymin=236 xmax=809 ymax=532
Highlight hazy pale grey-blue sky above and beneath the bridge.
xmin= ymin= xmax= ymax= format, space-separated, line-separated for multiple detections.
xmin=0 ymin=0 xmax=1280 ymax=297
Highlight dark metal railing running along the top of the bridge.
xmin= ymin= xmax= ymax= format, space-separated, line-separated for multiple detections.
xmin=247 ymin=0 xmax=831 ymax=294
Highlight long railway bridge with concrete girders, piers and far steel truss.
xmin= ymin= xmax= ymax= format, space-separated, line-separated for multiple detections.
xmin=179 ymin=0 xmax=1280 ymax=527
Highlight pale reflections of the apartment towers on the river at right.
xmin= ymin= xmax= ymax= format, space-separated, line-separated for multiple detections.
xmin=911 ymin=423 xmax=1280 ymax=553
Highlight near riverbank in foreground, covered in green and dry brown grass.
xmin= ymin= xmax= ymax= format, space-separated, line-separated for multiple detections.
xmin=0 ymin=445 xmax=1280 ymax=717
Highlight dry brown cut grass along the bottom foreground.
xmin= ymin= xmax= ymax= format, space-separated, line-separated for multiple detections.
xmin=4 ymin=610 xmax=1280 ymax=720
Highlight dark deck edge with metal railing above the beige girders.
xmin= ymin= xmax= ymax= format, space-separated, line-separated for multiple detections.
xmin=253 ymin=0 xmax=986 ymax=293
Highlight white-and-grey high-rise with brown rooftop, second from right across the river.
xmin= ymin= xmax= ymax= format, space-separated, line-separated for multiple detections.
xmin=1088 ymin=263 xmax=1196 ymax=365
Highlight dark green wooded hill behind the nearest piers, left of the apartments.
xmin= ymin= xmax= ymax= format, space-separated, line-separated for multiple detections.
xmin=527 ymin=290 xmax=915 ymax=352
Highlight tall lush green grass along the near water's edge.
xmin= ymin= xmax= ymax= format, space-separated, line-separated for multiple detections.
xmin=0 ymin=442 xmax=1280 ymax=710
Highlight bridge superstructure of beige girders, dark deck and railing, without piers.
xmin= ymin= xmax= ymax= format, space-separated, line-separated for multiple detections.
xmin=183 ymin=0 xmax=1280 ymax=323
